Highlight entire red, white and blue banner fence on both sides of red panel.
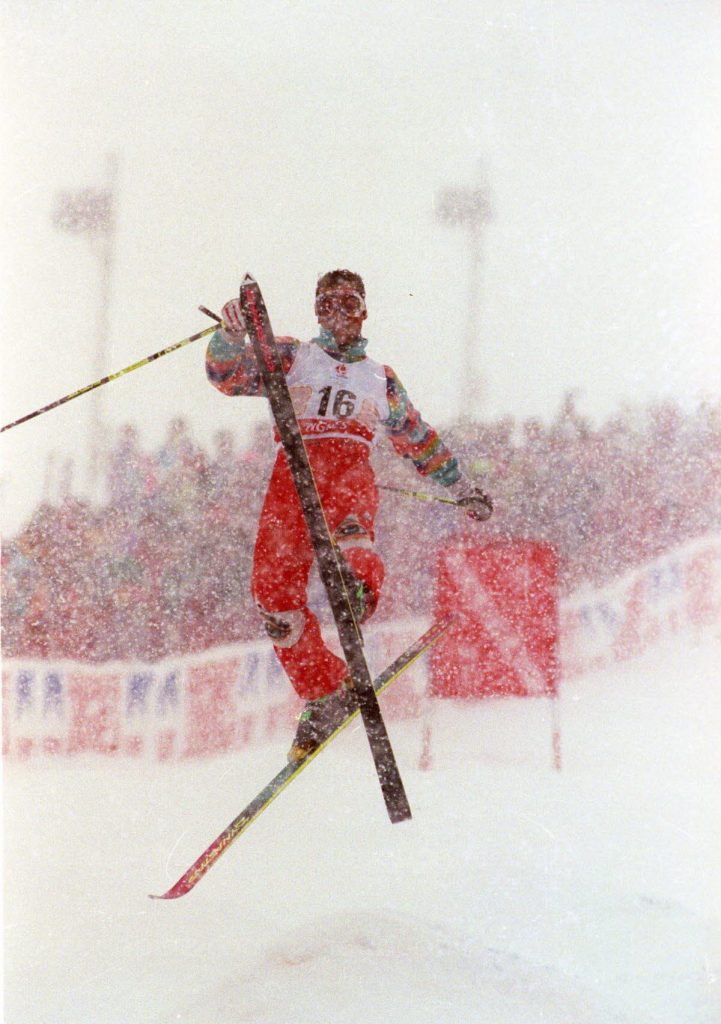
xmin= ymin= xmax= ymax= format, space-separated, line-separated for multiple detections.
xmin=2 ymin=535 xmax=721 ymax=761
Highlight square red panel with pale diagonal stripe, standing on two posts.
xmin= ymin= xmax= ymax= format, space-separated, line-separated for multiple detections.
xmin=431 ymin=541 xmax=559 ymax=697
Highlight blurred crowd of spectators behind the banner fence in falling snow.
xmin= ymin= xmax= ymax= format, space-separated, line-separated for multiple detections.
xmin=2 ymin=394 xmax=721 ymax=662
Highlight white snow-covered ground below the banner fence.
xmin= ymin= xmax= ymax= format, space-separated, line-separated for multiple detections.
xmin=4 ymin=640 xmax=721 ymax=1024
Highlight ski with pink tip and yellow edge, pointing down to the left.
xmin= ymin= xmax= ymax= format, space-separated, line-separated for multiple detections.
xmin=151 ymin=615 xmax=453 ymax=899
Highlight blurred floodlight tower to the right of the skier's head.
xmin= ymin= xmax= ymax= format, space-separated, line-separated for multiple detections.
xmin=435 ymin=186 xmax=492 ymax=420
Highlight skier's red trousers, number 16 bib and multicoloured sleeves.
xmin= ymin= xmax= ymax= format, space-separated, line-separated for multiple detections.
xmin=206 ymin=332 xmax=460 ymax=700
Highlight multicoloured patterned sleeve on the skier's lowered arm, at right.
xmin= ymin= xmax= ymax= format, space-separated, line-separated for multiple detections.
xmin=383 ymin=367 xmax=461 ymax=487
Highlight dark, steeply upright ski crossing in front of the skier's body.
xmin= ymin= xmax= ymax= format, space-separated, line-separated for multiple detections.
xmin=240 ymin=274 xmax=411 ymax=822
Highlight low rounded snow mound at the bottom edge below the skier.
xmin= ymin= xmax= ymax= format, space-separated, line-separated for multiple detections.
xmin=182 ymin=912 xmax=627 ymax=1024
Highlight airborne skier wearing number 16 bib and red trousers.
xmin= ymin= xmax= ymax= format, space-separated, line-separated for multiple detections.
xmin=206 ymin=270 xmax=493 ymax=762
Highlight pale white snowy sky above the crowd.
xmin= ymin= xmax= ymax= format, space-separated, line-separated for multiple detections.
xmin=0 ymin=0 xmax=721 ymax=532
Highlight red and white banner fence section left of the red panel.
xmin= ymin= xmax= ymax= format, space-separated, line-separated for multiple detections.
xmin=2 ymin=622 xmax=427 ymax=761
